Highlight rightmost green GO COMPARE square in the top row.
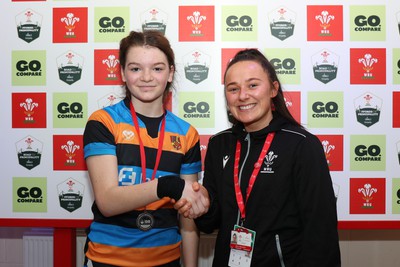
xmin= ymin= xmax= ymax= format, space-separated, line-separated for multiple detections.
xmin=349 ymin=5 xmax=386 ymax=41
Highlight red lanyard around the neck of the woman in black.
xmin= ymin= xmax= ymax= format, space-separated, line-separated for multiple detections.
xmin=233 ymin=132 xmax=275 ymax=222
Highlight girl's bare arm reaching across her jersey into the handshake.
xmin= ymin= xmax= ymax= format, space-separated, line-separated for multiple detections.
xmin=86 ymin=155 xmax=209 ymax=218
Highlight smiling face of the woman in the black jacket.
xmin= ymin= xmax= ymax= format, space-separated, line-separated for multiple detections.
xmin=225 ymin=61 xmax=279 ymax=132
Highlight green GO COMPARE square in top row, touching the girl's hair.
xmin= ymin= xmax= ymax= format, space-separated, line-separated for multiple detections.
xmin=93 ymin=6 xmax=130 ymax=43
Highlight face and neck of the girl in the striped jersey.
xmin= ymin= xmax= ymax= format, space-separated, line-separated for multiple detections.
xmin=121 ymin=46 xmax=174 ymax=116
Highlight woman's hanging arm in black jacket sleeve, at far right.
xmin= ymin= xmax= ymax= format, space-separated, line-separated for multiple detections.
xmin=294 ymin=136 xmax=340 ymax=267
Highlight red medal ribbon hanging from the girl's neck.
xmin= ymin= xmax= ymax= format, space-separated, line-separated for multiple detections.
xmin=130 ymin=102 xmax=165 ymax=183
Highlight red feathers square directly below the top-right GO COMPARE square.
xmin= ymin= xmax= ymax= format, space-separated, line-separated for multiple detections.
xmin=350 ymin=48 xmax=386 ymax=84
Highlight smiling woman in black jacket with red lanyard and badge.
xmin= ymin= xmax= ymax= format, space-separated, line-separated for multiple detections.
xmin=177 ymin=49 xmax=340 ymax=267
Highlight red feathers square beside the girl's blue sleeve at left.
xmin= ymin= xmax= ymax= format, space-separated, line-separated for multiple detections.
xmin=53 ymin=135 xmax=87 ymax=171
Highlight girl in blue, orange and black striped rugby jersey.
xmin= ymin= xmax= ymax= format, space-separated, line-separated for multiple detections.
xmin=84 ymin=31 xmax=209 ymax=267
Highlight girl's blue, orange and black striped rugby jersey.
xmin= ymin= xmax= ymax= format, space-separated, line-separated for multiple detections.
xmin=84 ymin=99 xmax=201 ymax=266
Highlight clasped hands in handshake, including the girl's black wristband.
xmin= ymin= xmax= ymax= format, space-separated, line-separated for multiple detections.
xmin=157 ymin=175 xmax=210 ymax=219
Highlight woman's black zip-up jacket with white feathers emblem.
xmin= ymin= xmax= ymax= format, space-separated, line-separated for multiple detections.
xmin=196 ymin=114 xmax=340 ymax=267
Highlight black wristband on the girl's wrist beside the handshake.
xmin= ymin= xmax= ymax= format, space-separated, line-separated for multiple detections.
xmin=157 ymin=175 xmax=185 ymax=200
